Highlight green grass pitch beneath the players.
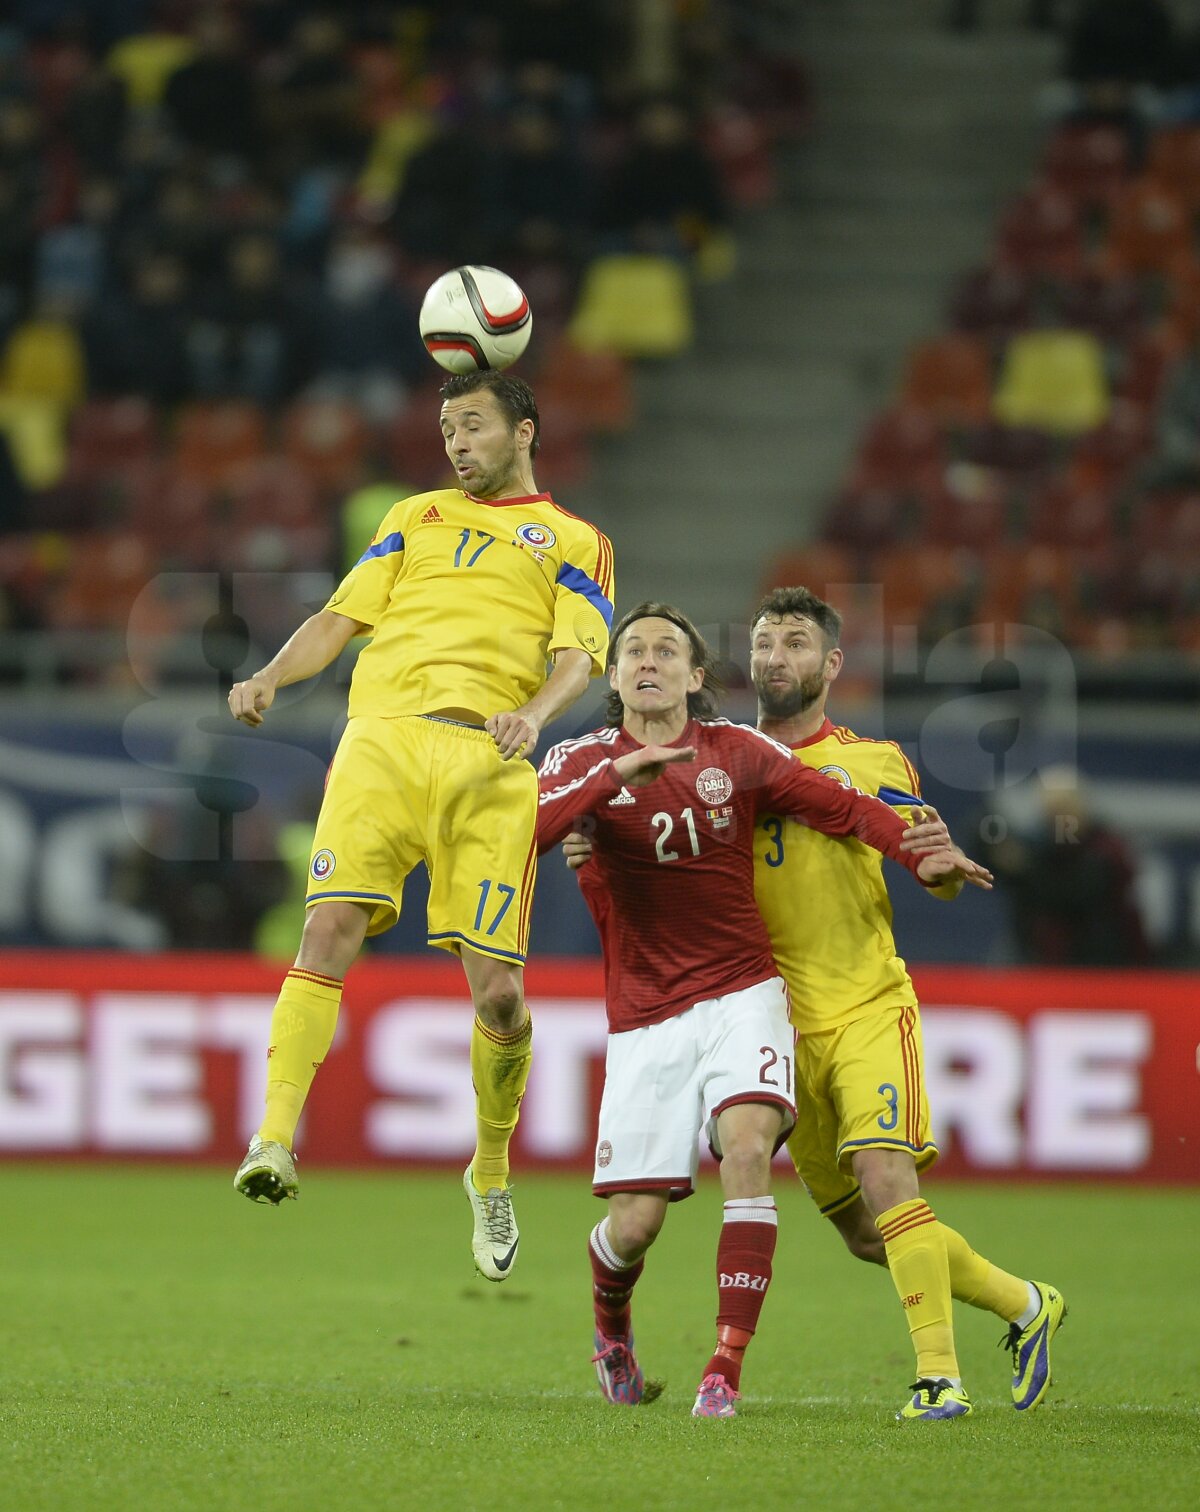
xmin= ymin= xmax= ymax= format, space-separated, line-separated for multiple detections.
xmin=0 ymin=1163 xmax=1200 ymax=1512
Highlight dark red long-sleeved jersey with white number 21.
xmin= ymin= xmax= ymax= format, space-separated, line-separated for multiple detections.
xmin=538 ymin=720 xmax=917 ymax=1033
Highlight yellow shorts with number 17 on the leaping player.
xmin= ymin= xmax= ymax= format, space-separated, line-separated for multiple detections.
xmin=305 ymin=715 xmax=538 ymax=963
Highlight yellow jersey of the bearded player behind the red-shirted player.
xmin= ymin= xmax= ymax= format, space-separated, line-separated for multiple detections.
xmin=754 ymin=720 xmax=920 ymax=1034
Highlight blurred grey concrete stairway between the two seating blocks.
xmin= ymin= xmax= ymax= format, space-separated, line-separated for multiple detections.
xmin=571 ymin=0 xmax=1059 ymax=627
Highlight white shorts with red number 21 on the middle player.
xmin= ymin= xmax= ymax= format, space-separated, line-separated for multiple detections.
xmin=592 ymin=977 xmax=796 ymax=1201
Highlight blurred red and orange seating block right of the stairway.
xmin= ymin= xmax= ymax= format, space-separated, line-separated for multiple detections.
xmin=768 ymin=0 xmax=1200 ymax=662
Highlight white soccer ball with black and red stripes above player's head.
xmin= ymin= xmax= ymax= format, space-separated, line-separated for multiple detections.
xmin=419 ymin=266 xmax=534 ymax=373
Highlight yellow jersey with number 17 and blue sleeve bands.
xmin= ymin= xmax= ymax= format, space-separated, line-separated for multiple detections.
xmin=325 ymin=488 xmax=614 ymax=720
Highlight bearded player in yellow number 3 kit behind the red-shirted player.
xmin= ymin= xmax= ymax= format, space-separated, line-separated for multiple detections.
xmin=750 ymin=588 xmax=1065 ymax=1421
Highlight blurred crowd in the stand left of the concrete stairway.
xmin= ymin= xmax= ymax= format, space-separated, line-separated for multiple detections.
xmin=0 ymin=0 xmax=806 ymax=674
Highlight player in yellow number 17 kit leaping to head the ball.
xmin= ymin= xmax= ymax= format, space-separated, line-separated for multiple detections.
xmin=230 ymin=372 xmax=614 ymax=1281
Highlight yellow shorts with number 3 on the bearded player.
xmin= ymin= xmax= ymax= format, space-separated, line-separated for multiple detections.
xmin=787 ymin=1002 xmax=937 ymax=1217
